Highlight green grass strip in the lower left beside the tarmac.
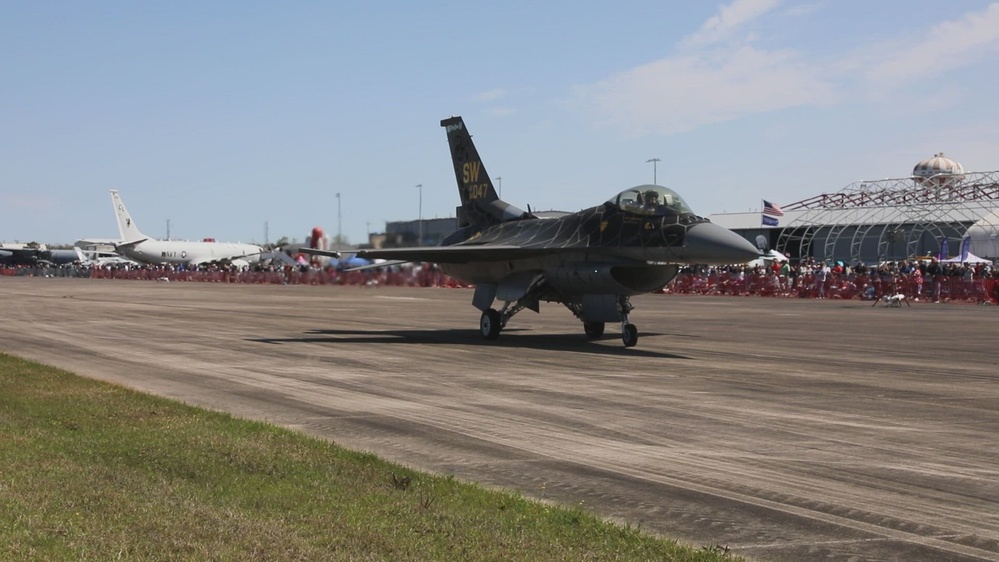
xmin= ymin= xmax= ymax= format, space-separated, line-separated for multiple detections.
xmin=0 ymin=353 xmax=735 ymax=562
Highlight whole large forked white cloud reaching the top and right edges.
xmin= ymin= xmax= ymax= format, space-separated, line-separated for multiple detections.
xmin=571 ymin=0 xmax=999 ymax=135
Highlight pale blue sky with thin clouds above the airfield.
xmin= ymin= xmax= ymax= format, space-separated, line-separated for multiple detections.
xmin=0 ymin=0 xmax=999 ymax=244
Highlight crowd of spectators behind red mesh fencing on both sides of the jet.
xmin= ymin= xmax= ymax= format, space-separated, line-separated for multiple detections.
xmin=7 ymin=258 xmax=999 ymax=304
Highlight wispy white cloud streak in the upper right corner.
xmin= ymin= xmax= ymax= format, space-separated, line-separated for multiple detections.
xmin=866 ymin=3 xmax=999 ymax=83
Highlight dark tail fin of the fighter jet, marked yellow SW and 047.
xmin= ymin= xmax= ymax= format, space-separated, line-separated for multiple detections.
xmin=441 ymin=116 xmax=532 ymax=227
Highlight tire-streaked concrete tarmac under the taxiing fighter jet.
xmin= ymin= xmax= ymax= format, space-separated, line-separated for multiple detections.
xmin=0 ymin=278 xmax=999 ymax=562
